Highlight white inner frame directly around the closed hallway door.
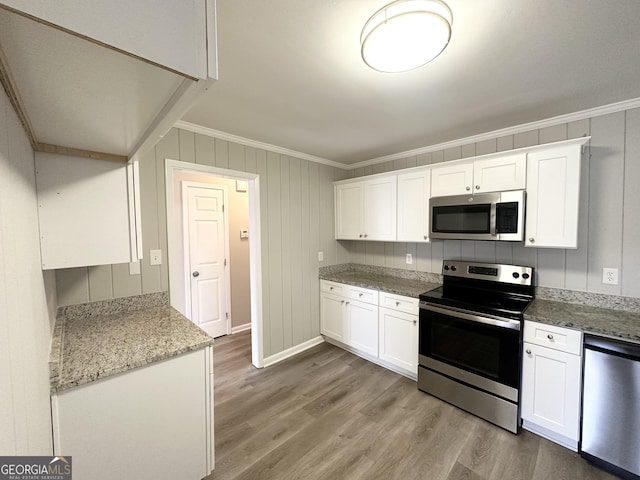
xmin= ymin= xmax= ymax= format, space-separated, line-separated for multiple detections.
xmin=180 ymin=180 xmax=232 ymax=335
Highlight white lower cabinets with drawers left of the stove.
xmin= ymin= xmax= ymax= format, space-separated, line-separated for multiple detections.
xmin=320 ymin=280 xmax=418 ymax=379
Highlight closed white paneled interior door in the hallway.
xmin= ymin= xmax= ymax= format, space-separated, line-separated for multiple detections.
xmin=183 ymin=182 xmax=229 ymax=337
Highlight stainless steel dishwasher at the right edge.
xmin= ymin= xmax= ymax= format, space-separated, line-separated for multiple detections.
xmin=581 ymin=335 xmax=640 ymax=480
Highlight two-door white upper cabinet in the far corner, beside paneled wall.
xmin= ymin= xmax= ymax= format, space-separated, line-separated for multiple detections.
xmin=335 ymin=175 xmax=397 ymax=241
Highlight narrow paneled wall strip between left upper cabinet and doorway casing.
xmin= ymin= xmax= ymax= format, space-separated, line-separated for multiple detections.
xmin=139 ymin=149 xmax=166 ymax=293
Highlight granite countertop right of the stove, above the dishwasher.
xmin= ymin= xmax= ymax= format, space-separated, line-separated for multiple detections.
xmin=524 ymin=299 xmax=640 ymax=344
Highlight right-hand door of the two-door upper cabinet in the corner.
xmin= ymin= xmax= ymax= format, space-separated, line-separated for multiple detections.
xmin=362 ymin=175 xmax=397 ymax=241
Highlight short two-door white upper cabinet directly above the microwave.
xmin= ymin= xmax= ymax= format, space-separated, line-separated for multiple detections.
xmin=431 ymin=153 xmax=527 ymax=197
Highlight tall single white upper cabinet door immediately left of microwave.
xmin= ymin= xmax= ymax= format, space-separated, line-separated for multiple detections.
xmin=397 ymin=169 xmax=431 ymax=242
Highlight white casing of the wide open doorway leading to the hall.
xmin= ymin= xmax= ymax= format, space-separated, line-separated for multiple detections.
xmin=164 ymin=158 xmax=264 ymax=368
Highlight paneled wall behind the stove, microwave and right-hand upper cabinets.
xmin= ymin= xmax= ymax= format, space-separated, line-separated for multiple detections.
xmin=340 ymin=109 xmax=640 ymax=297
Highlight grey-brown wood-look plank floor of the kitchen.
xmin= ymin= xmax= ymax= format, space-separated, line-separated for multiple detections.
xmin=207 ymin=332 xmax=616 ymax=480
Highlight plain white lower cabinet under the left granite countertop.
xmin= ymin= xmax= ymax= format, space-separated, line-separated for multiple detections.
xmin=51 ymin=347 xmax=214 ymax=480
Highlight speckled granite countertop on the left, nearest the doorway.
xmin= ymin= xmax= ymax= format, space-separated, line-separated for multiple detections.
xmin=49 ymin=304 xmax=214 ymax=393
